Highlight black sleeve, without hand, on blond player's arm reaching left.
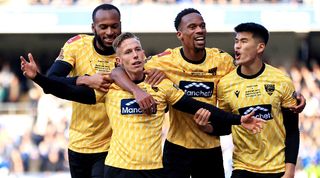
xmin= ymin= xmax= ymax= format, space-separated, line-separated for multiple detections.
xmin=33 ymin=73 xmax=96 ymax=104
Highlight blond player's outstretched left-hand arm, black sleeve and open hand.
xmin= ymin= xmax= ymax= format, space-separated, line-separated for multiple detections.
xmin=20 ymin=53 xmax=96 ymax=104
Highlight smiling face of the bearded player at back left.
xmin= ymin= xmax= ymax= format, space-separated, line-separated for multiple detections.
xmin=92 ymin=9 xmax=121 ymax=50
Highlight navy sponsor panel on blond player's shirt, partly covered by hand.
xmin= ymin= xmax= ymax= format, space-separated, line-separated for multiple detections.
xmin=120 ymin=99 xmax=157 ymax=115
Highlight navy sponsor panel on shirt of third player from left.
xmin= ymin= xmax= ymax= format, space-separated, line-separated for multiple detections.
xmin=179 ymin=81 xmax=214 ymax=98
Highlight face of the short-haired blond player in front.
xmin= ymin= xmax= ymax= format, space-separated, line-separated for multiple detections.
xmin=116 ymin=38 xmax=145 ymax=80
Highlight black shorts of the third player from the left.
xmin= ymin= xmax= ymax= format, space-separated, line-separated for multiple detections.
xmin=163 ymin=140 xmax=225 ymax=178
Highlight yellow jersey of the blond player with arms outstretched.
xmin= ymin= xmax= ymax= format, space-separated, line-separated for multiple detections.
xmin=105 ymin=79 xmax=184 ymax=170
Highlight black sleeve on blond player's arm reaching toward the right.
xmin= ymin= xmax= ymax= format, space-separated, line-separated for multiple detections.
xmin=173 ymin=95 xmax=241 ymax=126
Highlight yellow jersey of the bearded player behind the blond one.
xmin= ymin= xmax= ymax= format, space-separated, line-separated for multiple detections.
xmin=57 ymin=35 xmax=115 ymax=153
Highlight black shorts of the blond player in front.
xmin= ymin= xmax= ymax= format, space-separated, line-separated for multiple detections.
xmin=104 ymin=165 xmax=166 ymax=178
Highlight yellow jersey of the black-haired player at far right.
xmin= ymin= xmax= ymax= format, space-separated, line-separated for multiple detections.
xmin=218 ymin=64 xmax=296 ymax=173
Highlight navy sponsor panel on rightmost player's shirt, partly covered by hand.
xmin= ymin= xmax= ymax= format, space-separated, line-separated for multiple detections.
xmin=239 ymin=104 xmax=273 ymax=120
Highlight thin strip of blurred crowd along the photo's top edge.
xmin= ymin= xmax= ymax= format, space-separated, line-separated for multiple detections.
xmin=0 ymin=0 xmax=316 ymax=6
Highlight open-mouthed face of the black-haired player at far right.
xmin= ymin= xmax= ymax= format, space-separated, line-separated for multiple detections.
xmin=234 ymin=32 xmax=265 ymax=66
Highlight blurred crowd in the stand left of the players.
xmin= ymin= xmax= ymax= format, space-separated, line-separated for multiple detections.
xmin=0 ymin=59 xmax=71 ymax=177
